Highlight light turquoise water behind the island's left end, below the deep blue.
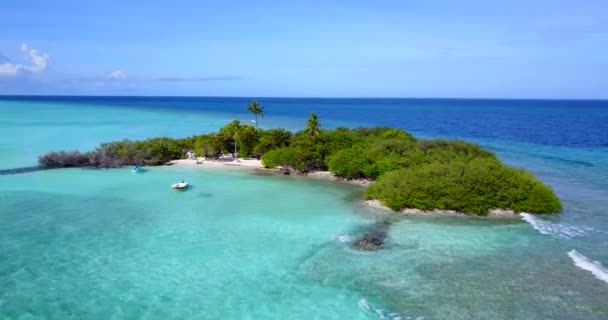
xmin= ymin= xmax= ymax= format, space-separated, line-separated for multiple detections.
xmin=0 ymin=99 xmax=350 ymax=169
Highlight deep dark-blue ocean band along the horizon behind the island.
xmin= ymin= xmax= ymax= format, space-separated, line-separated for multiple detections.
xmin=9 ymin=96 xmax=608 ymax=148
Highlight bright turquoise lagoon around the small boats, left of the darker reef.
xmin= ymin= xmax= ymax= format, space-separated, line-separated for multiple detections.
xmin=0 ymin=168 xmax=373 ymax=319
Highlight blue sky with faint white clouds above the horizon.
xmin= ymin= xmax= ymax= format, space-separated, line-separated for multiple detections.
xmin=0 ymin=0 xmax=608 ymax=99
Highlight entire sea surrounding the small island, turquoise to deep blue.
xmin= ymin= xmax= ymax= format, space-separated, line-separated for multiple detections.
xmin=0 ymin=97 xmax=608 ymax=320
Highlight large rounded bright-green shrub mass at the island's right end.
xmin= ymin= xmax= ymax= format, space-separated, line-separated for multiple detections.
xmin=366 ymin=158 xmax=562 ymax=214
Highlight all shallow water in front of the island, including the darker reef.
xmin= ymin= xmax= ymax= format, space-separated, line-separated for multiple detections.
xmin=0 ymin=167 xmax=608 ymax=319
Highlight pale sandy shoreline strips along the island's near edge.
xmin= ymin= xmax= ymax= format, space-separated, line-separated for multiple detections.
xmin=166 ymin=157 xmax=521 ymax=218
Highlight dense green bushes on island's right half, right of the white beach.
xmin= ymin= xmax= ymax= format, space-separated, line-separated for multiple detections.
xmin=262 ymin=120 xmax=562 ymax=215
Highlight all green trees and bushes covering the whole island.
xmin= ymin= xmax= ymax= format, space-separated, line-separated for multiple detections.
xmin=39 ymin=104 xmax=562 ymax=215
